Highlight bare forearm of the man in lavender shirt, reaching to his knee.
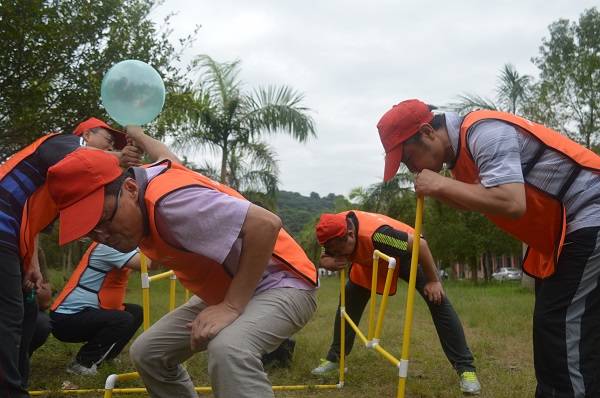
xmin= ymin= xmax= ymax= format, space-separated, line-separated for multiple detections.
xmin=224 ymin=205 xmax=281 ymax=314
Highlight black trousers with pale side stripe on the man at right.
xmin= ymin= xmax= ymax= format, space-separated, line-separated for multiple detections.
xmin=533 ymin=227 xmax=600 ymax=398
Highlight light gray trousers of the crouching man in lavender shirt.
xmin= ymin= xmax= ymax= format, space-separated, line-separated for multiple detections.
xmin=129 ymin=288 xmax=317 ymax=398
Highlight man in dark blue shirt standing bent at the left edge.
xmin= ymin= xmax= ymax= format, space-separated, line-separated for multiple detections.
xmin=0 ymin=118 xmax=140 ymax=397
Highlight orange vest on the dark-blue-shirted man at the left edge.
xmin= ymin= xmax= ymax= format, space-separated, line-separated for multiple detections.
xmin=0 ymin=133 xmax=58 ymax=271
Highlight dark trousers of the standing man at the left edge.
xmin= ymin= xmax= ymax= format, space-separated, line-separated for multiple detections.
xmin=0 ymin=248 xmax=37 ymax=398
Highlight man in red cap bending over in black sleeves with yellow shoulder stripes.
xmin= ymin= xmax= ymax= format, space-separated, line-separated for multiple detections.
xmin=312 ymin=210 xmax=481 ymax=394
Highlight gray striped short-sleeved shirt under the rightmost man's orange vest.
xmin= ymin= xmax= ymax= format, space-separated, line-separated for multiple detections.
xmin=445 ymin=113 xmax=600 ymax=233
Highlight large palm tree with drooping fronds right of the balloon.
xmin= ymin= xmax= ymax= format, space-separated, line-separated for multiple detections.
xmin=175 ymin=55 xmax=316 ymax=189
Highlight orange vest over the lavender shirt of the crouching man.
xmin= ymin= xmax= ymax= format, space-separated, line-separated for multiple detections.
xmin=139 ymin=160 xmax=318 ymax=305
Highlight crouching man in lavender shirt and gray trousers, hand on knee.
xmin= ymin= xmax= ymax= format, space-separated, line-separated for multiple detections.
xmin=48 ymin=127 xmax=317 ymax=398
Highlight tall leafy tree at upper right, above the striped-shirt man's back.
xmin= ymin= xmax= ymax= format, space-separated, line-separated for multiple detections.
xmin=532 ymin=7 xmax=600 ymax=148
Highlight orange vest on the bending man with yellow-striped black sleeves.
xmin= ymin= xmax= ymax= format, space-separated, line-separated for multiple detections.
xmin=340 ymin=210 xmax=414 ymax=295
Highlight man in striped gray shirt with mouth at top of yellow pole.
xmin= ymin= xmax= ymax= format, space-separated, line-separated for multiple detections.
xmin=377 ymin=99 xmax=600 ymax=398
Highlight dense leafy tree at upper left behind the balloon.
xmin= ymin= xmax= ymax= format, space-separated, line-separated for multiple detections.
xmin=0 ymin=0 xmax=191 ymax=160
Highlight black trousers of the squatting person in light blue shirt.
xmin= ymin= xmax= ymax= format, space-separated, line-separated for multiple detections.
xmin=50 ymin=304 xmax=143 ymax=368
